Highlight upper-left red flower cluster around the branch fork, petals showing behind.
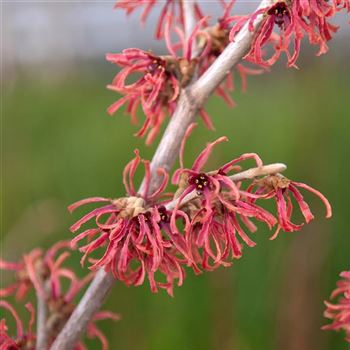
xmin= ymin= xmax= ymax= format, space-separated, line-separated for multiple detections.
xmin=106 ymin=7 xmax=264 ymax=144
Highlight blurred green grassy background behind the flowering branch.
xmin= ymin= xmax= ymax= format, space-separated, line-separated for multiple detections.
xmin=2 ymin=59 xmax=350 ymax=350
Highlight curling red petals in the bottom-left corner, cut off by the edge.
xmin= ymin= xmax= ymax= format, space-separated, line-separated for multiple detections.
xmin=0 ymin=300 xmax=36 ymax=350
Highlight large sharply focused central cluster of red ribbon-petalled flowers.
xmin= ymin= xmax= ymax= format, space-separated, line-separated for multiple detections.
xmin=70 ymin=131 xmax=331 ymax=295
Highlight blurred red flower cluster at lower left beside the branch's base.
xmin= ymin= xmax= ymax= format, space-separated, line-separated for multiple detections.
xmin=0 ymin=241 xmax=119 ymax=350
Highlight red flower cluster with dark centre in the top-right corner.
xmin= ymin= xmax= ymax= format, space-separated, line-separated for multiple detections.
xmin=230 ymin=0 xmax=350 ymax=66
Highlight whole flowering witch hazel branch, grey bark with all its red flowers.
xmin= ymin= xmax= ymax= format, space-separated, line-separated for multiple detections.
xmin=0 ymin=0 xmax=350 ymax=350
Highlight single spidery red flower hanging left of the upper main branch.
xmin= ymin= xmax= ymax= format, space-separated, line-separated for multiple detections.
xmin=107 ymin=49 xmax=180 ymax=144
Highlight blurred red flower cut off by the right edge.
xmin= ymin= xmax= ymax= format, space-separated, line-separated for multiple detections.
xmin=322 ymin=271 xmax=350 ymax=342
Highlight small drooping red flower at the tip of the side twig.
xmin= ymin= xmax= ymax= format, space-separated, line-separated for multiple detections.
xmin=248 ymin=174 xmax=332 ymax=239
